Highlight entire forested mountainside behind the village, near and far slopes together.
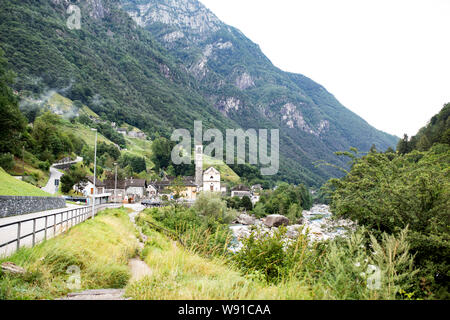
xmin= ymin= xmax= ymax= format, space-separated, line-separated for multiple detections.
xmin=0 ymin=0 xmax=398 ymax=186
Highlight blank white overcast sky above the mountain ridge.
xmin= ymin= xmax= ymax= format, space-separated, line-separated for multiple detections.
xmin=200 ymin=0 xmax=450 ymax=137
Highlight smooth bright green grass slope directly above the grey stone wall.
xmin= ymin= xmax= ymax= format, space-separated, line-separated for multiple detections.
xmin=0 ymin=168 xmax=52 ymax=197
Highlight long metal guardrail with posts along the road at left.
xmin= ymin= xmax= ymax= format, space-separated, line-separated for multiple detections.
xmin=0 ymin=204 xmax=121 ymax=256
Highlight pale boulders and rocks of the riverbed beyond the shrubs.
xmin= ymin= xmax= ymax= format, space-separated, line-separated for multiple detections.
xmin=230 ymin=204 xmax=355 ymax=252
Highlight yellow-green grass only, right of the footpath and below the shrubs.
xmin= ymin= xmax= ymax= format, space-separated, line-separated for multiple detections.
xmin=126 ymin=212 xmax=312 ymax=300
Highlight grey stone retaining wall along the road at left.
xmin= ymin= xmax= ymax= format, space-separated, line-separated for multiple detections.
xmin=0 ymin=196 xmax=66 ymax=218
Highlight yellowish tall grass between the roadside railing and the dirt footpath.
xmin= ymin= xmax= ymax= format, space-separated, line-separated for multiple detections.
xmin=0 ymin=208 xmax=137 ymax=300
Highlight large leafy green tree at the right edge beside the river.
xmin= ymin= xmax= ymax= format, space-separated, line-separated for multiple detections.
xmin=329 ymin=144 xmax=450 ymax=299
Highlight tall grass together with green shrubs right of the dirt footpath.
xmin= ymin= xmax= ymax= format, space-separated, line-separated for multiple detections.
xmin=136 ymin=208 xmax=416 ymax=300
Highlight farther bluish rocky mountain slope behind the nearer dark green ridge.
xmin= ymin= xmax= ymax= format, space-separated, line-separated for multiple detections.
xmin=122 ymin=0 xmax=398 ymax=180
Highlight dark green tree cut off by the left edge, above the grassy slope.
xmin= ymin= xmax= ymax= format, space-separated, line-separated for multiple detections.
xmin=0 ymin=49 xmax=27 ymax=155
